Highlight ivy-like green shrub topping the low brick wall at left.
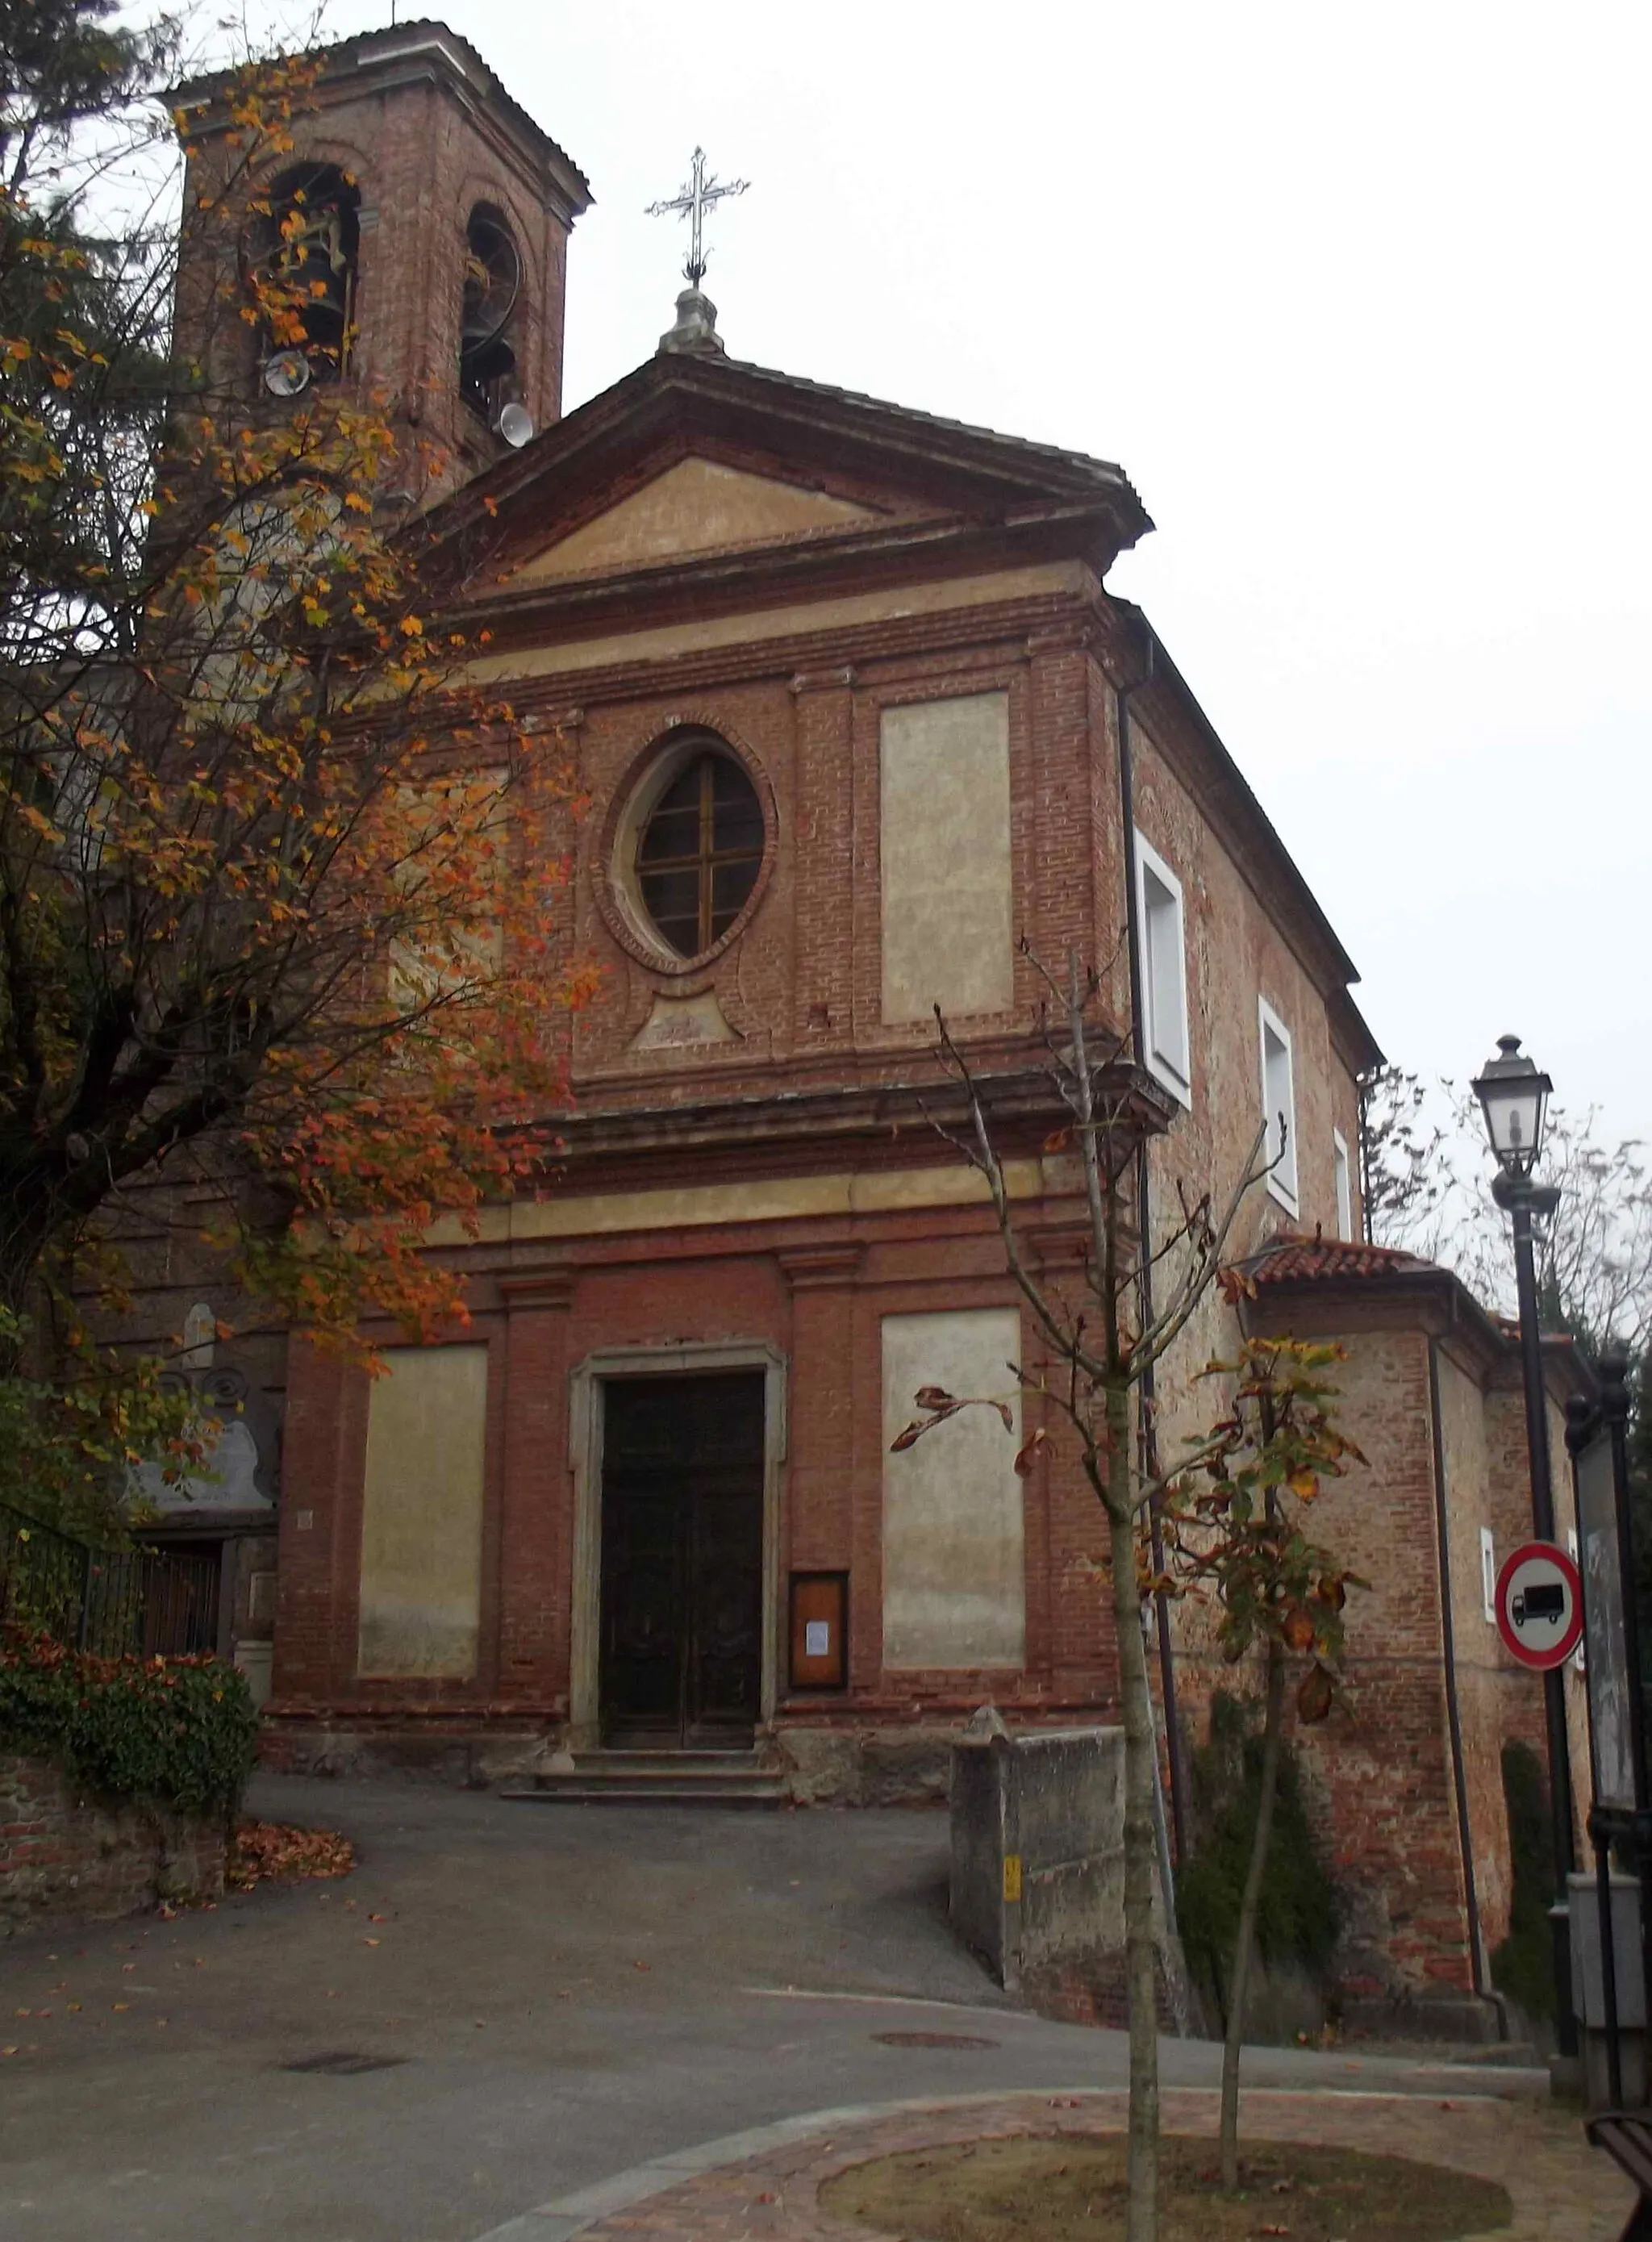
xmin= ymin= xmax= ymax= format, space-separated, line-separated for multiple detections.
xmin=0 ymin=1628 xmax=258 ymax=1816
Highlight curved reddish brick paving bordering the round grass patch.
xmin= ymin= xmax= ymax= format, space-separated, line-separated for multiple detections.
xmin=478 ymin=2087 xmax=1634 ymax=2242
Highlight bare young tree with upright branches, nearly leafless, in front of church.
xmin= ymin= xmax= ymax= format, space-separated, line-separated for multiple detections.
xmin=895 ymin=941 xmax=1269 ymax=2242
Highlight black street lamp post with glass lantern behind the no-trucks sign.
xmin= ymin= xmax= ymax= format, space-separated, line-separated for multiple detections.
xmin=1473 ymin=1036 xmax=1578 ymax=2056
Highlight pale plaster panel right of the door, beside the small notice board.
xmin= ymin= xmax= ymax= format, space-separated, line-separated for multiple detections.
xmin=883 ymin=1307 xmax=1027 ymax=1668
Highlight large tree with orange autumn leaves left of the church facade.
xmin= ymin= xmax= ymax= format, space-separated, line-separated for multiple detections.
xmin=0 ymin=0 xmax=582 ymax=1515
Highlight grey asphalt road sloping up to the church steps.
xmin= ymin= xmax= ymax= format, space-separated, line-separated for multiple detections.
xmin=0 ymin=1778 xmax=1604 ymax=2242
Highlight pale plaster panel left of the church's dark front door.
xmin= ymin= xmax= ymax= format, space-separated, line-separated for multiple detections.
xmin=359 ymin=1345 xmax=489 ymax=1681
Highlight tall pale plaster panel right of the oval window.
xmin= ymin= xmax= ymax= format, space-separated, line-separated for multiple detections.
xmin=878 ymin=693 xmax=1016 ymax=1022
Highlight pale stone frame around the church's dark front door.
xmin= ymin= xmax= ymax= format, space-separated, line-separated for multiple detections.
xmin=567 ymin=1341 xmax=786 ymax=1751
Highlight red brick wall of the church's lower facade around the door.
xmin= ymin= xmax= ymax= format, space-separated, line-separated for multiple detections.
xmin=276 ymin=1202 xmax=1116 ymax=1735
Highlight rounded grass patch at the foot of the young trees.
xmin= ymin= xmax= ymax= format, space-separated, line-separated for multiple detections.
xmin=820 ymin=2135 xmax=1513 ymax=2242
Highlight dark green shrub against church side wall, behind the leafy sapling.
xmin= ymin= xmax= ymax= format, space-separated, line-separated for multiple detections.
xmin=1177 ymin=1690 xmax=1343 ymax=2006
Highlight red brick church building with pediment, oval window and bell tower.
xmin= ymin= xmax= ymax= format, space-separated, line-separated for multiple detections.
xmin=154 ymin=23 xmax=1583 ymax=2053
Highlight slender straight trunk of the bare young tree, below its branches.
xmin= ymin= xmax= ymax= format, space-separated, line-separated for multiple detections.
xmin=1108 ymin=1388 xmax=1159 ymax=2242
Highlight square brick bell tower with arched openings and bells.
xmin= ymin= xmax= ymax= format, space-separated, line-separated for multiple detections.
xmin=175 ymin=23 xmax=592 ymax=504
